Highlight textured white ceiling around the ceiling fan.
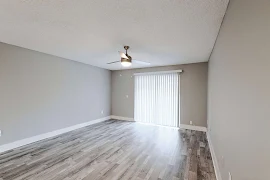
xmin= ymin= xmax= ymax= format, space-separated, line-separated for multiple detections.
xmin=0 ymin=0 xmax=229 ymax=70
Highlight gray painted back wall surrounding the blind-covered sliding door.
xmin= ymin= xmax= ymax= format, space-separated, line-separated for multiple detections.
xmin=111 ymin=63 xmax=208 ymax=127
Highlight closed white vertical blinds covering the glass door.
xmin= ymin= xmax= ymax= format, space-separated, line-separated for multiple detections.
xmin=134 ymin=73 xmax=179 ymax=127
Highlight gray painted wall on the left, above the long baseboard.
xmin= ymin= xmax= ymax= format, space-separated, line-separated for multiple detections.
xmin=0 ymin=43 xmax=111 ymax=145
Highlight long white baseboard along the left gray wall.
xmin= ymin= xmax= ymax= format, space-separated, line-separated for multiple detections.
xmin=0 ymin=116 xmax=111 ymax=153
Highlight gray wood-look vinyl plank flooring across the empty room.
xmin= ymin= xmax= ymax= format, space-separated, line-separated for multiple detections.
xmin=0 ymin=120 xmax=216 ymax=180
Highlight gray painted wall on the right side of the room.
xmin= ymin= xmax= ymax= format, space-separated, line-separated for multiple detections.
xmin=208 ymin=0 xmax=270 ymax=180
